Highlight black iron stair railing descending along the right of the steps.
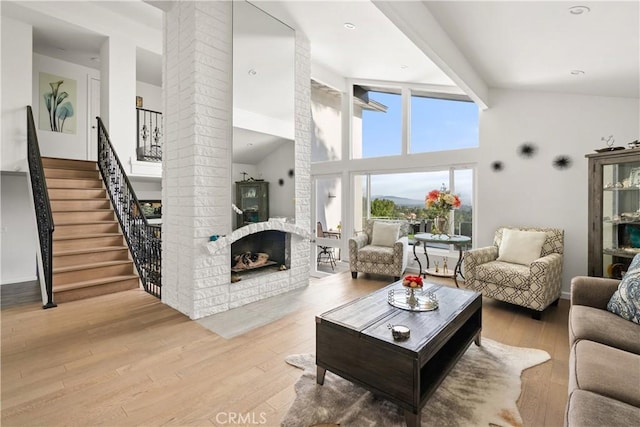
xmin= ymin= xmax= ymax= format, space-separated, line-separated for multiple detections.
xmin=97 ymin=117 xmax=162 ymax=298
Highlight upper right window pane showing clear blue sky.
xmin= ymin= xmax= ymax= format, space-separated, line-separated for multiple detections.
xmin=409 ymin=94 xmax=478 ymax=153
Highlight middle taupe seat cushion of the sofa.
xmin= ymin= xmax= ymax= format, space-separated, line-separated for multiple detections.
xmin=569 ymin=340 xmax=640 ymax=406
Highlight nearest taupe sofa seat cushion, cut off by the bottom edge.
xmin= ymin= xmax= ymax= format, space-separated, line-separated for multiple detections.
xmin=565 ymin=390 xmax=640 ymax=427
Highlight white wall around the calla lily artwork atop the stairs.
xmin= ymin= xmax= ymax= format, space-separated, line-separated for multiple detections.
xmin=31 ymin=53 xmax=100 ymax=160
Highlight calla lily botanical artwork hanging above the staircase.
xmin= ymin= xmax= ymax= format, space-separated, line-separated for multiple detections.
xmin=38 ymin=72 xmax=78 ymax=135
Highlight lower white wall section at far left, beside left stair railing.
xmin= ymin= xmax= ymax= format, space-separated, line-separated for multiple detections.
xmin=0 ymin=173 xmax=39 ymax=285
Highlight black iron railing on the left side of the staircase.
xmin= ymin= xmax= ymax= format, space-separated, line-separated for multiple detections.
xmin=27 ymin=106 xmax=56 ymax=308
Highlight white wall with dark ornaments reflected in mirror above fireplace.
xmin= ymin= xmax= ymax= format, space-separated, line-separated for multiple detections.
xmin=257 ymin=142 xmax=296 ymax=218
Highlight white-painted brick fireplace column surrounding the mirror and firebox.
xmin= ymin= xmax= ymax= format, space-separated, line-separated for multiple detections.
xmin=162 ymin=2 xmax=311 ymax=319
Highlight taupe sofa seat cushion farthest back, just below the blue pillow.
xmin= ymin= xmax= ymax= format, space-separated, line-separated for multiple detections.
xmin=569 ymin=305 xmax=640 ymax=354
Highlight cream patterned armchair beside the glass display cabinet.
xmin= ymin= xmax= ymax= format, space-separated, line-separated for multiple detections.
xmin=463 ymin=227 xmax=564 ymax=319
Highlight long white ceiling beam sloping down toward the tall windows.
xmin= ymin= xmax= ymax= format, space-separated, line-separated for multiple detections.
xmin=373 ymin=0 xmax=489 ymax=110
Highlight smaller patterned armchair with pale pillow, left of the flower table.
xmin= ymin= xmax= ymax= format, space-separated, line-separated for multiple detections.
xmin=349 ymin=219 xmax=409 ymax=280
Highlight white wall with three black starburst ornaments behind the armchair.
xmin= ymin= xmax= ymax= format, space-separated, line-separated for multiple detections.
xmin=474 ymin=90 xmax=640 ymax=296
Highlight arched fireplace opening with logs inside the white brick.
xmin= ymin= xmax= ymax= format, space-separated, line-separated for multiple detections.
xmin=231 ymin=230 xmax=291 ymax=281
